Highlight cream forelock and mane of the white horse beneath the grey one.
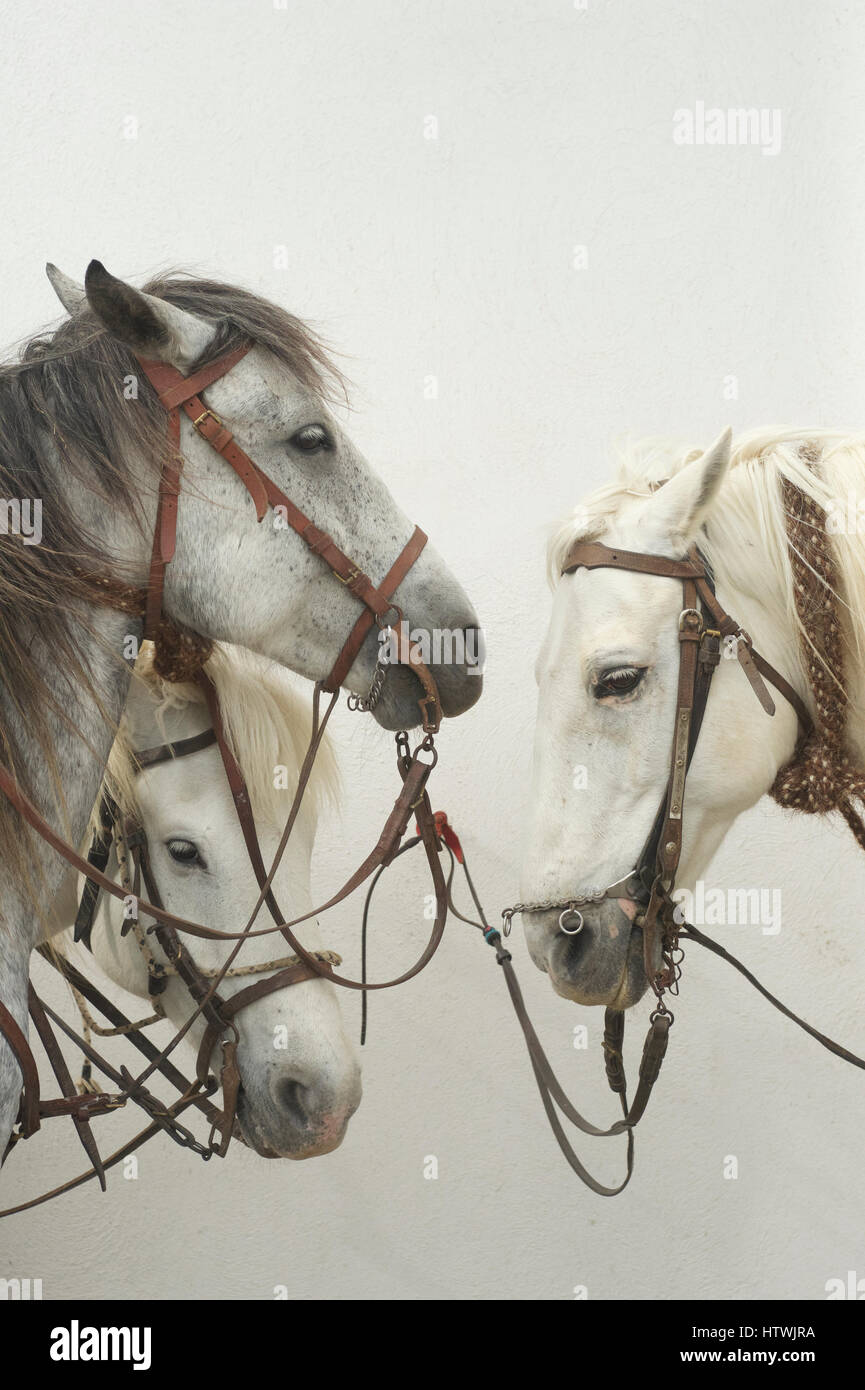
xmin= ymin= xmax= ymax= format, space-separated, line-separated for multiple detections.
xmin=89 ymin=642 xmax=339 ymax=834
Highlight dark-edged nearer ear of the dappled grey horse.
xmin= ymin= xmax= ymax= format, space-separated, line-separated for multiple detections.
xmin=85 ymin=261 xmax=216 ymax=368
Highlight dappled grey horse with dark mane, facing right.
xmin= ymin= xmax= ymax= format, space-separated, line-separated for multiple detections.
xmin=0 ymin=261 xmax=481 ymax=1151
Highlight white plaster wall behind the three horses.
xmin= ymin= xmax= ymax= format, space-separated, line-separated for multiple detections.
xmin=0 ymin=0 xmax=865 ymax=1300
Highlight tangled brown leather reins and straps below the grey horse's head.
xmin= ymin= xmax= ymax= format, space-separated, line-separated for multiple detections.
xmin=0 ymin=687 xmax=448 ymax=1215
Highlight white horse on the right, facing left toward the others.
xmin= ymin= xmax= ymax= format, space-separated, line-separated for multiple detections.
xmin=522 ymin=431 xmax=865 ymax=1008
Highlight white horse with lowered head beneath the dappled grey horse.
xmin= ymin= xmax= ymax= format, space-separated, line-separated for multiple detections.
xmin=54 ymin=646 xmax=360 ymax=1158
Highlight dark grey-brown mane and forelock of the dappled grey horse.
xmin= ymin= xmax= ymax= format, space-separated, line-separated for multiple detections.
xmin=0 ymin=271 xmax=345 ymax=878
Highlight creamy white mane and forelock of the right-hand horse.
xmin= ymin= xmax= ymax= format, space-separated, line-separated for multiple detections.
xmin=548 ymin=428 xmax=865 ymax=759
